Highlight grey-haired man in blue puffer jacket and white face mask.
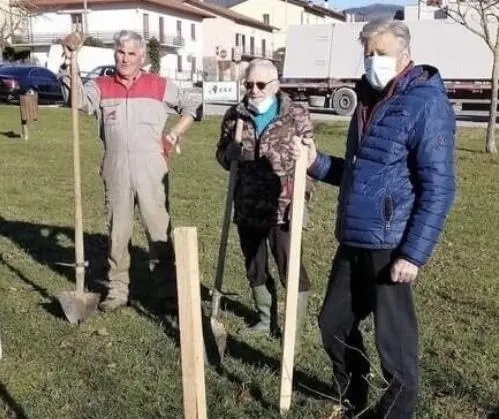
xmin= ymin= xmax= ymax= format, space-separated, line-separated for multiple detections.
xmin=294 ymin=20 xmax=455 ymax=419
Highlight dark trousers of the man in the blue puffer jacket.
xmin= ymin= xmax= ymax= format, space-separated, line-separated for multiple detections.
xmin=319 ymin=245 xmax=419 ymax=419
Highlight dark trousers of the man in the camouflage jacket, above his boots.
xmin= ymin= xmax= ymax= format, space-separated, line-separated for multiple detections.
xmin=237 ymin=224 xmax=310 ymax=292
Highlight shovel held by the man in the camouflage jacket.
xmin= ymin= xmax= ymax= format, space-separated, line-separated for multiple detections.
xmin=210 ymin=119 xmax=243 ymax=359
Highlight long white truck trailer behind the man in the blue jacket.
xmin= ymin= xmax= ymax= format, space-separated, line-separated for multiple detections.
xmin=281 ymin=20 xmax=493 ymax=115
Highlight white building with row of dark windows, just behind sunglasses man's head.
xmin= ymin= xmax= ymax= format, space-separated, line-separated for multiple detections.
xmin=183 ymin=0 xmax=277 ymax=81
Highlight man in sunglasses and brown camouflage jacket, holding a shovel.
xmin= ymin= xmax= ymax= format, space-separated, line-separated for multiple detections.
xmin=216 ymin=59 xmax=313 ymax=344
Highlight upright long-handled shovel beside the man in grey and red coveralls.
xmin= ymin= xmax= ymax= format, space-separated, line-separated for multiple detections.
xmin=56 ymin=52 xmax=100 ymax=324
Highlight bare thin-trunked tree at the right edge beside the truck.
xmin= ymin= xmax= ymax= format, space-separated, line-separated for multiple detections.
xmin=443 ymin=0 xmax=499 ymax=153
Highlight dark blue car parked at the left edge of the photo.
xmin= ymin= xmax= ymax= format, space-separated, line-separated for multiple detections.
xmin=0 ymin=65 xmax=64 ymax=104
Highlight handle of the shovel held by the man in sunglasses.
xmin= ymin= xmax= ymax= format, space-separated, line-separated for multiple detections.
xmin=211 ymin=119 xmax=243 ymax=317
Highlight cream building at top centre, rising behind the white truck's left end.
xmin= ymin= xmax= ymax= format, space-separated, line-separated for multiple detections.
xmin=230 ymin=0 xmax=346 ymax=50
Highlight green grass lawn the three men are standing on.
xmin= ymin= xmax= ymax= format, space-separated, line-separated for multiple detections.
xmin=0 ymin=107 xmax=499 ymax=419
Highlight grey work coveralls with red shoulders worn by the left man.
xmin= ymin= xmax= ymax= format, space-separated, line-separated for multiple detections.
xmin=59 ymin=70 xmax=202 ymax=299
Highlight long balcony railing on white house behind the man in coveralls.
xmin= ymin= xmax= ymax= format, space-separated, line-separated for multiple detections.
xmin=12 ymin=30 xmax=185 ymax=48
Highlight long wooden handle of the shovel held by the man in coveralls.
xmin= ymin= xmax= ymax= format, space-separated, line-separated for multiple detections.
xmin=71 ymin=52 xmax=85 ymax=292
